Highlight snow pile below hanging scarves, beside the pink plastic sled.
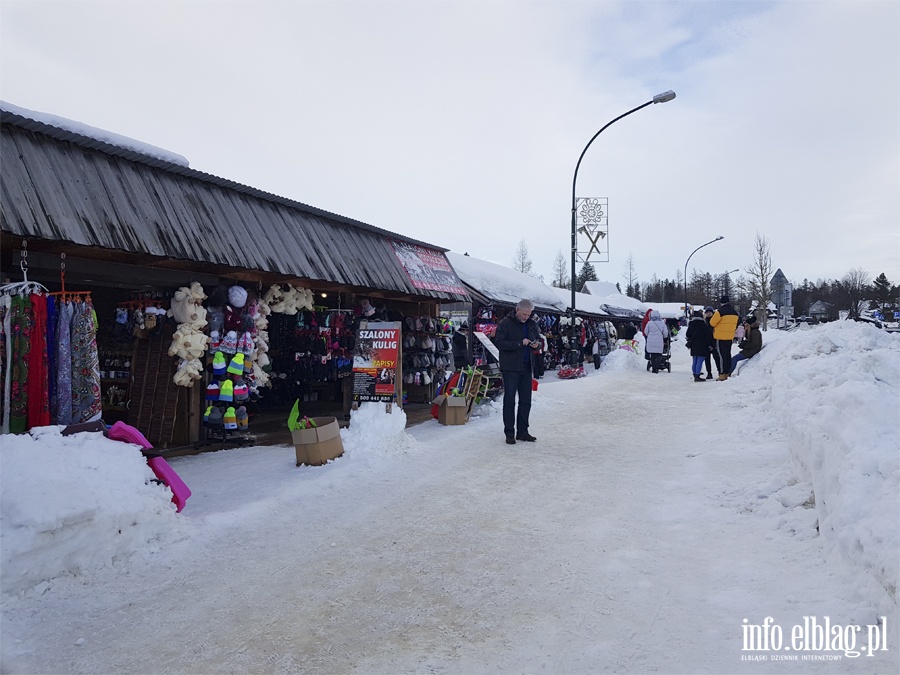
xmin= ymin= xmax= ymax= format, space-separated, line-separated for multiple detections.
xmin=0 ymin=426 xmax=183 ymax=591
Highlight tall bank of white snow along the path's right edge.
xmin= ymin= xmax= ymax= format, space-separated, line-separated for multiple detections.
xmin=738 ymin=321 xmax=900 ymax=602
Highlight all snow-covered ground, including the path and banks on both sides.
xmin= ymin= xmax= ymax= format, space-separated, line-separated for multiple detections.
xmin=0 ymin=322 xmax=900 ymax=673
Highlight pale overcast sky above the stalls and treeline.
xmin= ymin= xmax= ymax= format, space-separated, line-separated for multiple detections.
xmin=0 ymin=0 xmax=900 ymax=288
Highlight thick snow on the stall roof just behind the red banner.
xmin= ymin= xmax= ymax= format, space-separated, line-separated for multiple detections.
xmin=446 ymin=251 xmax=566 ymax=312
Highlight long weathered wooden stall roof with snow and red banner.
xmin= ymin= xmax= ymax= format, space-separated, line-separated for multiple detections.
xmin=0 ymin=102 xmax=468 ymax=301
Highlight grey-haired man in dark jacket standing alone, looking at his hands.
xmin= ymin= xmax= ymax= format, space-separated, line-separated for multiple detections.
xmin=494 ymin=299 xmax=541 ymax=445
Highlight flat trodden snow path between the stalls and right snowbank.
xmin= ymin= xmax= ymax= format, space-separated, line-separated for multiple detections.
xmin=5 ymin=342 xmax=900 ymax=673
